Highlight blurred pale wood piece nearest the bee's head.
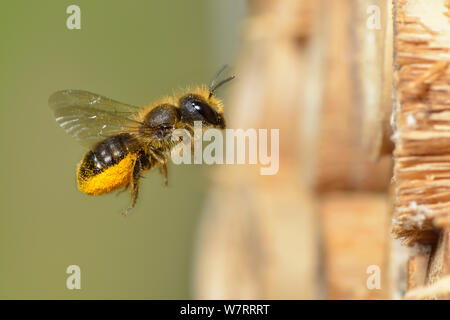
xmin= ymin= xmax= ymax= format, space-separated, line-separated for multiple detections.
xmin=194 ymin=1 xmax=320 ymax=299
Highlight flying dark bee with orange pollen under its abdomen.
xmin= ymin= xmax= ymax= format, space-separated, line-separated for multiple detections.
xmin=49 ymin=66 xmax=234 ymax=215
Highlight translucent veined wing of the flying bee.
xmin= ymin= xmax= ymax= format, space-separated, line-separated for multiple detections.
xmin=48 ymin=90 xmax=141 ymax=147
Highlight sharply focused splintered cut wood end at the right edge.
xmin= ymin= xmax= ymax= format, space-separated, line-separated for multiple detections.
xmin=392 ymin=0 xmax=450 ymax=244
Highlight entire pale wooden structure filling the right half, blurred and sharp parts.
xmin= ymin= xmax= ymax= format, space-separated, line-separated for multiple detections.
xmin=194 ymin=0 xmax=450 ymax=299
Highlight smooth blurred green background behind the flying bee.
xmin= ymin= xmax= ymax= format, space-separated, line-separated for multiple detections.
xmin=0 ymin=0 xmax=246 ymax=299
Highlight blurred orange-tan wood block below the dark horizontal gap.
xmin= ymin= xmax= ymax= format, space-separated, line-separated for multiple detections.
xmin=320 ymin=192 xmax=389 ymax=299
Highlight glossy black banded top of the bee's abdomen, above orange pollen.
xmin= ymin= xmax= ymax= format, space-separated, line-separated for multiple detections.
xmin=80 ymin=133 xmax=136 ymax=176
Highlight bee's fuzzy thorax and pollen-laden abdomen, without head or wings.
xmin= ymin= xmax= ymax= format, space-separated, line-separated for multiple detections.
xmin=77 ymin=102 xmax=181 ymax=195
